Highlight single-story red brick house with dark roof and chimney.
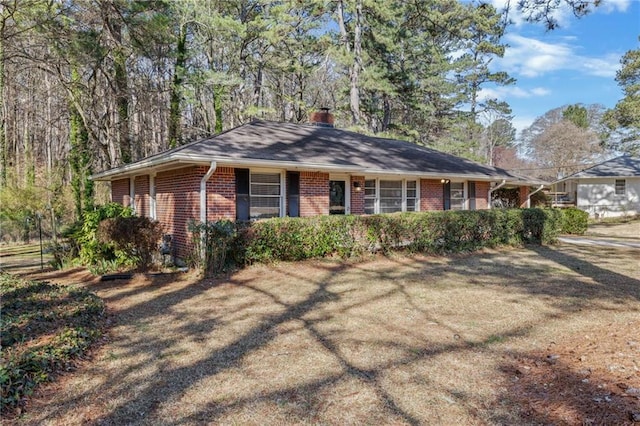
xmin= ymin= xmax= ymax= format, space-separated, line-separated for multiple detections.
xmin=92 ymin=112 xmax=541 ymax=256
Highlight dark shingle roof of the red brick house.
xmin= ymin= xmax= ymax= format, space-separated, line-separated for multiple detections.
xmin=94 ymin=120 xmax=544 ymax=184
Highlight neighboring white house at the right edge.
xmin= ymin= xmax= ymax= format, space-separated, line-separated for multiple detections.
xmin=551 ymin=155 xmax=640 ymax=217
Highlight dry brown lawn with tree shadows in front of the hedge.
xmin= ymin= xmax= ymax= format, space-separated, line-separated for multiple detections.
xmin=10 ymin=245 xmax=640 ymax=425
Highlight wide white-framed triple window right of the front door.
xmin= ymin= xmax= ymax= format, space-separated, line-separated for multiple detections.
xmin=364 ymin=179 xmax=419 ymax=214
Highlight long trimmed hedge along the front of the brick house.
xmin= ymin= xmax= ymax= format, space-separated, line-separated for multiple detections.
xmin=192 ymin=208 xmax=565 ymax=274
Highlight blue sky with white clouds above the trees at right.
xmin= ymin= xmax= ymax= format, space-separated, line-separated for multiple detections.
xmin=485 ymin=0 xmax=640 ymax=137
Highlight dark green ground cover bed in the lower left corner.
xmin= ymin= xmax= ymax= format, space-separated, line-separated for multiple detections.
xmin=0 ymin=274 xmax=105 ymax=413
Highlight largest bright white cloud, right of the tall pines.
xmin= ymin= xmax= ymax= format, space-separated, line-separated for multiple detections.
xmin=495 ymin=34 xmax=619 ymax=78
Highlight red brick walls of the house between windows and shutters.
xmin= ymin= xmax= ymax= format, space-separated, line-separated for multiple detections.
xmin=111 ymin=166 xmax=504 ymax=258
